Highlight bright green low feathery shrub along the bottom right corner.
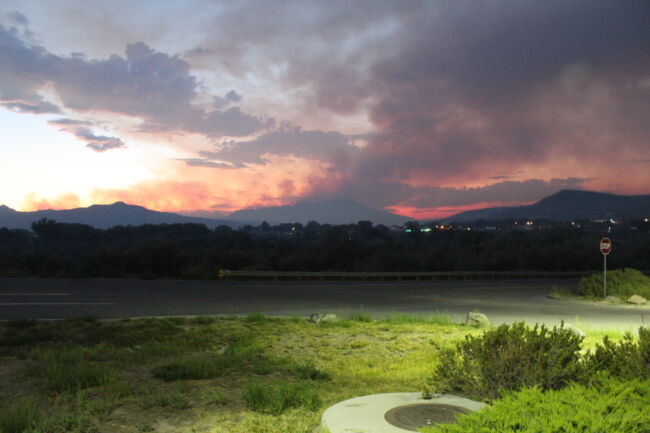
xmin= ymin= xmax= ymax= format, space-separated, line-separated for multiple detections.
xmin=422 ymin=378 xmax=650 ymax=433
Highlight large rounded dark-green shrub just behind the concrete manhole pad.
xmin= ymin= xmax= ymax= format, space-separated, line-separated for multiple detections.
xmin=424 ymin=323 xmax=582 ymax=400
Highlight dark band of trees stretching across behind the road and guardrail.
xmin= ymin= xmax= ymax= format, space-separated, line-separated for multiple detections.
xmin=0 ymin=219 xmax=650 ymax=279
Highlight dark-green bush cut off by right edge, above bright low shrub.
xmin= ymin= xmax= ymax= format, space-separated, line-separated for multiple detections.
xmin=585 ymin=328 xmax=650 ymax=379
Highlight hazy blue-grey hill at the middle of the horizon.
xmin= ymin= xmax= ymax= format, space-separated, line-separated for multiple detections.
xmin=228 ymin=200 xmax=410 ymax=226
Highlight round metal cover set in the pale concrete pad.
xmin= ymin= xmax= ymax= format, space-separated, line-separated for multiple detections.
xmin=384 ymin=403 xmax=469 ymax=431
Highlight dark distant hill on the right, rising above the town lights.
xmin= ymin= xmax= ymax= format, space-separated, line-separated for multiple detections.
xmin=445 ymin=189 xmax=650 ymax=222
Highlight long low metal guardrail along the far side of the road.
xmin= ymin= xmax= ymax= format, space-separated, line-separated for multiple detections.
xmin=219 ymin=269 xmax=597 ymax=281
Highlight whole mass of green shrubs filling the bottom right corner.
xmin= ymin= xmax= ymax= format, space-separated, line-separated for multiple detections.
xmin=423 ymin=323 xmax=650 ymax=433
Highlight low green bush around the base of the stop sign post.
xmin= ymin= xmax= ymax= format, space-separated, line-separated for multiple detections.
xmin=578 ymin=268 xmax=650 ymax=298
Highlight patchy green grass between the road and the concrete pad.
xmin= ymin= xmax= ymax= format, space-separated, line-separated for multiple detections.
xmin=0 ymin=314 xmax=620 ymax=433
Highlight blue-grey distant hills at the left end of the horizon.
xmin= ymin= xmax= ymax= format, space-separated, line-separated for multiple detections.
xmin=0 ymin=202 xmax=241 ymax=229
